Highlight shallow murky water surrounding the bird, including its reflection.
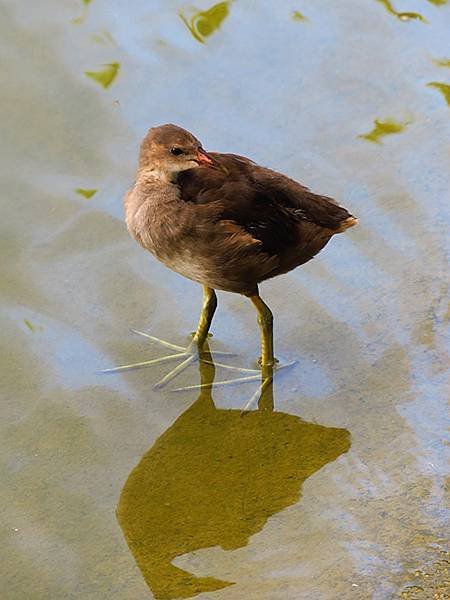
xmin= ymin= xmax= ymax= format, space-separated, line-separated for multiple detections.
xmin=0 ymin=0 xmax=450 ymax=600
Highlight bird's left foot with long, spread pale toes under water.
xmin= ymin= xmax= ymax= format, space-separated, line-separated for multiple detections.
xmin=102 ymin=329 xmax=246 ymax=389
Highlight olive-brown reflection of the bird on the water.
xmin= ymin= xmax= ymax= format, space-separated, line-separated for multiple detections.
xmin=117 ymin=346 xmax=350 ymax=599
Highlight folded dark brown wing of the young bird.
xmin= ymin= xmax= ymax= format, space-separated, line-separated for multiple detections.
xmin=178 ymin=153 xmax=356 ymax=255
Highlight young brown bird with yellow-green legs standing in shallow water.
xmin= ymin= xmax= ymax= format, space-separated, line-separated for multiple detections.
xmin=118 ymin=123 xmax=358 ymax=386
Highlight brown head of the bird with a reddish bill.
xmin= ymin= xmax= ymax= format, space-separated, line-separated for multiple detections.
xmin=139 ymin=123 xmax=215 ymax=181
